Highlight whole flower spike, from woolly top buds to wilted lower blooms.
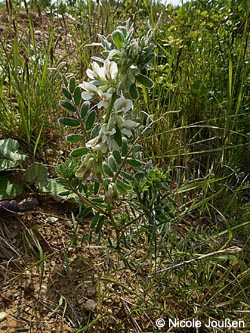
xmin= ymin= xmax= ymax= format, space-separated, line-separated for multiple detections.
xmin=72 ymin=21 xmax=154 ymax=187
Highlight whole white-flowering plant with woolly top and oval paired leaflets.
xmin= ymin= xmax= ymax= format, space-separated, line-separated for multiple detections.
xmin=59 ymin=20 xmax=175 ymax=239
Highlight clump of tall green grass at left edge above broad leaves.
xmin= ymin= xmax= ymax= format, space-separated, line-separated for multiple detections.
xmin=0 ymin=2 xmax=60 ymax=156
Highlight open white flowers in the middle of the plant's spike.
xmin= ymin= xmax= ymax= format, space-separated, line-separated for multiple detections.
xmin=79 ymin=51 xmax=139 ymax=153
